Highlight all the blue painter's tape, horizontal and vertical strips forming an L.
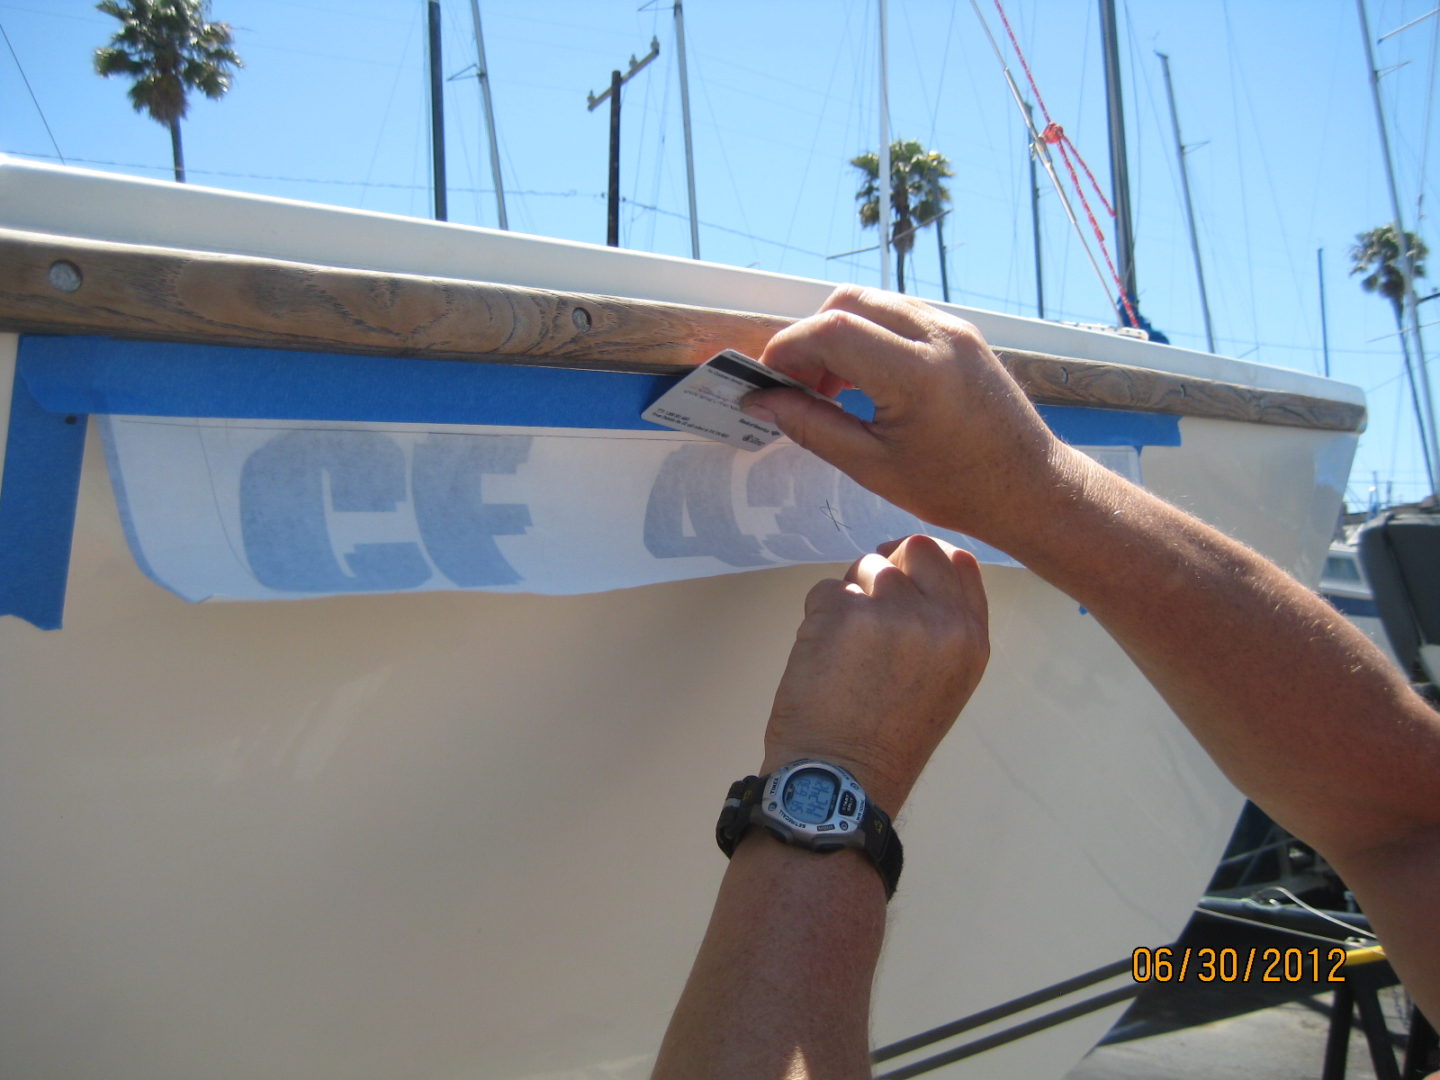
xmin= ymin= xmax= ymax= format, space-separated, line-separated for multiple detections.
xmin=0 ymin=336 xmax=1181 ymax=629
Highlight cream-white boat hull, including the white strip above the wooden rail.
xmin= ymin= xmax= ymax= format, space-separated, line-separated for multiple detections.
xmin=0 ymin=166 xmax=1355 ymax=1080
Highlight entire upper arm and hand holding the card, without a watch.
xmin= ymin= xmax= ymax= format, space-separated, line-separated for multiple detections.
xmin=752 ymin=288 xmax=1440 ymax=1015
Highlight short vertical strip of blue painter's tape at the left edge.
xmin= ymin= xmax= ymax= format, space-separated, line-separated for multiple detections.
xmin=0 ymin=365 xmax=86 ymax=629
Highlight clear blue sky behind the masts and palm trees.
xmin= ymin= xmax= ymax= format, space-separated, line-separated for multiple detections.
xmin=0 ymin=0 xmax=1440 ymax=503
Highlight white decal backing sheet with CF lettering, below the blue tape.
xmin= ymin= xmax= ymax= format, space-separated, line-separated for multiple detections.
xmin=101 ymin=416 xmax=1048 ymax=602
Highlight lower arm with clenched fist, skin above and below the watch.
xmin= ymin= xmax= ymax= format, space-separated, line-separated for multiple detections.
xmin=654 ymin=537 xmax=989 ymax=1080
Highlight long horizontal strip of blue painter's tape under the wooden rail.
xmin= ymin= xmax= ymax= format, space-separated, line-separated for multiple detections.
xmin=19 ymin=336 xmax=1179 ymax=448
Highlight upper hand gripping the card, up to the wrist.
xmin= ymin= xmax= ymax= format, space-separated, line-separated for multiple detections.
xmin=746 ymin=285 xmax=1081 ymax=547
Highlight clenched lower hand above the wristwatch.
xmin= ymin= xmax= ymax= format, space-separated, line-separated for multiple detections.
xmin=763 ymin=536 xmax=989 ymax=815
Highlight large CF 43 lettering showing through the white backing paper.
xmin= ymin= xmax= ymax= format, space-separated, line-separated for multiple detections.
xmin=239 ymin=429 xmax=914 ymax=593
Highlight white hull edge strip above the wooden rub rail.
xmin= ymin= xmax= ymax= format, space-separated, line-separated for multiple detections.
xmin=0 ymin=154 xmax=1364 ymax=405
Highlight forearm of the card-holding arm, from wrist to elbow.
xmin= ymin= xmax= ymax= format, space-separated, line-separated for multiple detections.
xmin=998 ymin=454 xmax=1440 ymax=860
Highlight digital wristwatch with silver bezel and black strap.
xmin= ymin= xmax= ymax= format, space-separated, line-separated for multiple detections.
xmin=716 ymin=757 xmax=904 ymax=900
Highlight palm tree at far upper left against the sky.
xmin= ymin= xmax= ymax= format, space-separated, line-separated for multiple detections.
xmin=95 ymin=0 xmax=245 ymax=184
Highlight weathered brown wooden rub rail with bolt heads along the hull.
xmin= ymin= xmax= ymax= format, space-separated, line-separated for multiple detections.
xmin=0 ymin=229 xmax=1365 ymax=431
